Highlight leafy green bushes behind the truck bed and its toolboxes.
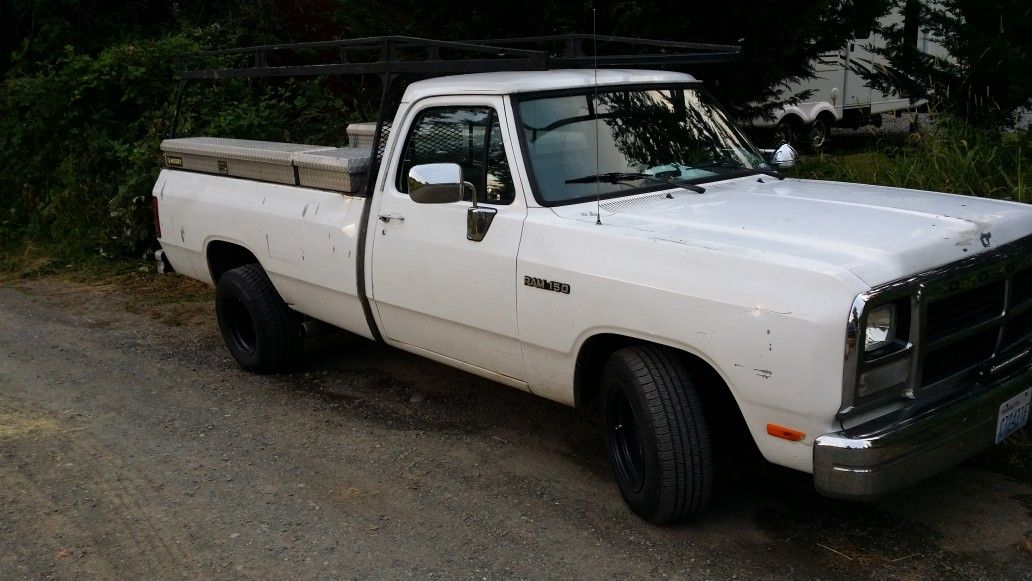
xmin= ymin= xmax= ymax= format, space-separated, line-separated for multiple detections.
xmin=0 ymin=27 xmax=360 ymax=259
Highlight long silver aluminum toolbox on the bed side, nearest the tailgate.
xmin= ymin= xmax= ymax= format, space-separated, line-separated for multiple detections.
xmin=161 ymin=137 xmax=332 ymax=184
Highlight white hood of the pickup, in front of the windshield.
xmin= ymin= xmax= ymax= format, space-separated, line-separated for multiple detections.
xmin=552 ymin=175 xmax=1032 ymax=287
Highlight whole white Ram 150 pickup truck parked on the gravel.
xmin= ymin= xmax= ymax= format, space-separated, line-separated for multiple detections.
xmin=154 ymin=70 xmax=1032 ymax=522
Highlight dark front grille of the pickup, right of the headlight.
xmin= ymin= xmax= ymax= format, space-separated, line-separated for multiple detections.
xmin=921 ymin=266 xmax=1032 ymax=387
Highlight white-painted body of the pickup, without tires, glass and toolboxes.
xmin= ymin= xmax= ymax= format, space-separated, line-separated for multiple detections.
xmin=154 ymin=70 xmax=1032 ymax=518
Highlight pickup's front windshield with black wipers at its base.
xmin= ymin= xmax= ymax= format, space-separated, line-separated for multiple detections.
xmin=519 ymin=86 xmax=770 ymax=203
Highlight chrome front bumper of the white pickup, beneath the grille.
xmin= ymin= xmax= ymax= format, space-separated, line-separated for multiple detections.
xmin=813 ymin=368 xmax=1032 ymax=499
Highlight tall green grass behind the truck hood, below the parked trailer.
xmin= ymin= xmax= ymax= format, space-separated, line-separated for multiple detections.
xmin=791 ymin=117 xmax=1032 ymax=202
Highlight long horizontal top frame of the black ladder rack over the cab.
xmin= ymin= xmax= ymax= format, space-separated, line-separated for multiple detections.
xmin=180 ymin=34 xmax=741 ymax=80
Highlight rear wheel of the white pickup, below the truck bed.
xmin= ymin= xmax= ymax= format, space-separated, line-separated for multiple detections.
xmin=215 ymin=264 xmax=304 ymax=374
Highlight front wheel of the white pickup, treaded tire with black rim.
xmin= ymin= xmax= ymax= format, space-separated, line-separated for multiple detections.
xmin=602 ymin=346 xmax=713 ymax=524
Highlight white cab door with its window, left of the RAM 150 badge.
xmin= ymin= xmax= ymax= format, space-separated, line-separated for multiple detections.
xmin=370 ymin=97 xmax=526 ymax=382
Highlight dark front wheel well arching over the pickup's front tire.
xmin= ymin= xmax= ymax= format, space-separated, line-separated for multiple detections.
xmin=574 ymin=333 xmax=754 ymax=449
